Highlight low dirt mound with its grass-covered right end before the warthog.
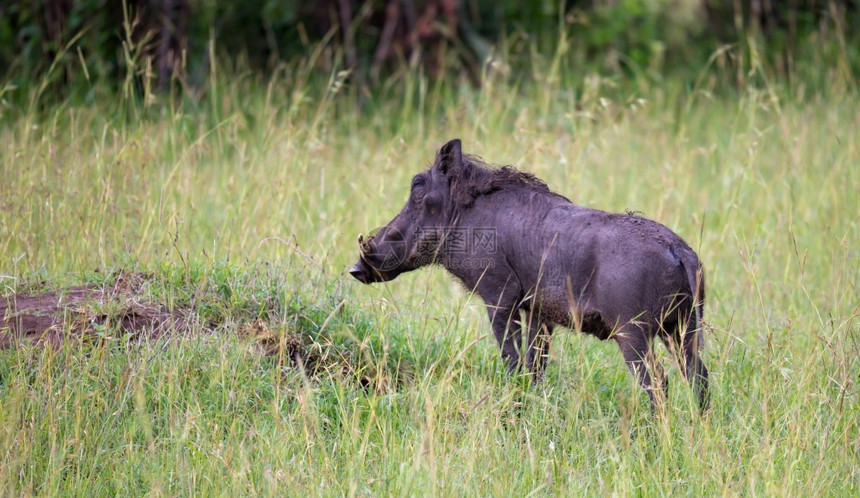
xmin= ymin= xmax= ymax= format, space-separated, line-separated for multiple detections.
xmin=0 ymin=267 xmax=414 ymax=393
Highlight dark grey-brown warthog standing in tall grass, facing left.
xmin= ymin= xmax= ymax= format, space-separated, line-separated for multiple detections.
xmin=350 ymin=140 xmax=708 ymax=410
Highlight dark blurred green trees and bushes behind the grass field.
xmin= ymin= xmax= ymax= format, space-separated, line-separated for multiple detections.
xmin=0 ymin=0 xmax=860 ymax=99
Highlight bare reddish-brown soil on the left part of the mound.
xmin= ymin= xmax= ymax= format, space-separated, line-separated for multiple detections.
xmin=0 ymin=275 xmax=184 ymax=349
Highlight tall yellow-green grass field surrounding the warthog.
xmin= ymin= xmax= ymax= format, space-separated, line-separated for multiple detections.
xmin=0 ymin=59 xmax=860 ymax=496
